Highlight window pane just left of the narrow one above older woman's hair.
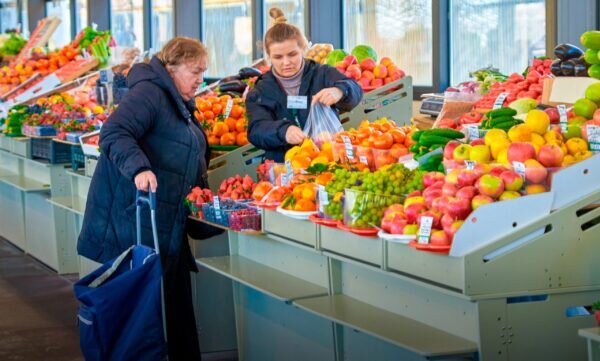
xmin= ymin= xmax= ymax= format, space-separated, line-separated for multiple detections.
xmin=110 ymin=0 xmax=144 ymax=50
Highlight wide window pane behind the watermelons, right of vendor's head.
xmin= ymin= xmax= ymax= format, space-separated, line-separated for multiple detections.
xmin=344 ymin=0 xmax=433 ymax=86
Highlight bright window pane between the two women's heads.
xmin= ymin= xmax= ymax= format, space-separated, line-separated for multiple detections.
xmin=202 ymin=0 xmax=252 ymax=77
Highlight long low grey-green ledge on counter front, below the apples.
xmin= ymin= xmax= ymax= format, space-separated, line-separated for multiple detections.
xmin=293 ymin=294 xmax=477 ymax=357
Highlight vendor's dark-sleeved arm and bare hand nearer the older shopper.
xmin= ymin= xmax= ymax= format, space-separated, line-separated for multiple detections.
xmin=246 ymin=90 xmax=304 ymax=150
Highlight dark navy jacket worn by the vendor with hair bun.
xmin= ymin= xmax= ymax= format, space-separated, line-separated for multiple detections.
xmin=246 ymin=59 xmax=363 ymax=162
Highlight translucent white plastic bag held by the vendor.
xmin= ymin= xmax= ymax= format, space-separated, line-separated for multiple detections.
xmin=304 ymin=102 xmax=343 ymax=149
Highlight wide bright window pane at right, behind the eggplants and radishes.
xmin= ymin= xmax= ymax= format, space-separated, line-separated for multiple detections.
xmin=450 ymin=0 xmax=546 ymax=84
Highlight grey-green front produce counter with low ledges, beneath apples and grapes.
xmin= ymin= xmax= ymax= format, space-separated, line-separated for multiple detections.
xmin=197 ymin=157 xmax=600 ymax=360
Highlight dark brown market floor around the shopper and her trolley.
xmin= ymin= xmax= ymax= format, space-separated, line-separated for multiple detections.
xmin=0 ymin=237 xmax=237 ymax=361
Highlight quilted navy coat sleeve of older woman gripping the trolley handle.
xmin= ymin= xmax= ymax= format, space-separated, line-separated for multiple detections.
xmin=100 ymin=87 xmax=160 ymax=181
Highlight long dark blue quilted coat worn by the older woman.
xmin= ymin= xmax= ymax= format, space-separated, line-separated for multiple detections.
xmin=77 ymin=58 xmax=209 ymax=263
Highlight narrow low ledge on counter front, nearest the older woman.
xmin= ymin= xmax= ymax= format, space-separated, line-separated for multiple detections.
xmin=196 ymin=256 xmax=327 ymax=302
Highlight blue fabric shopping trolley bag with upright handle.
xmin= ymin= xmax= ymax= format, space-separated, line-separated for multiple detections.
xmin=74 ymin=191 xmax=167 ymax=361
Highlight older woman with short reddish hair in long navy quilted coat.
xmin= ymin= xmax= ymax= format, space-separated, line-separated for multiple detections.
xmin=77 ymin=37 xmax=209 ymax=360
